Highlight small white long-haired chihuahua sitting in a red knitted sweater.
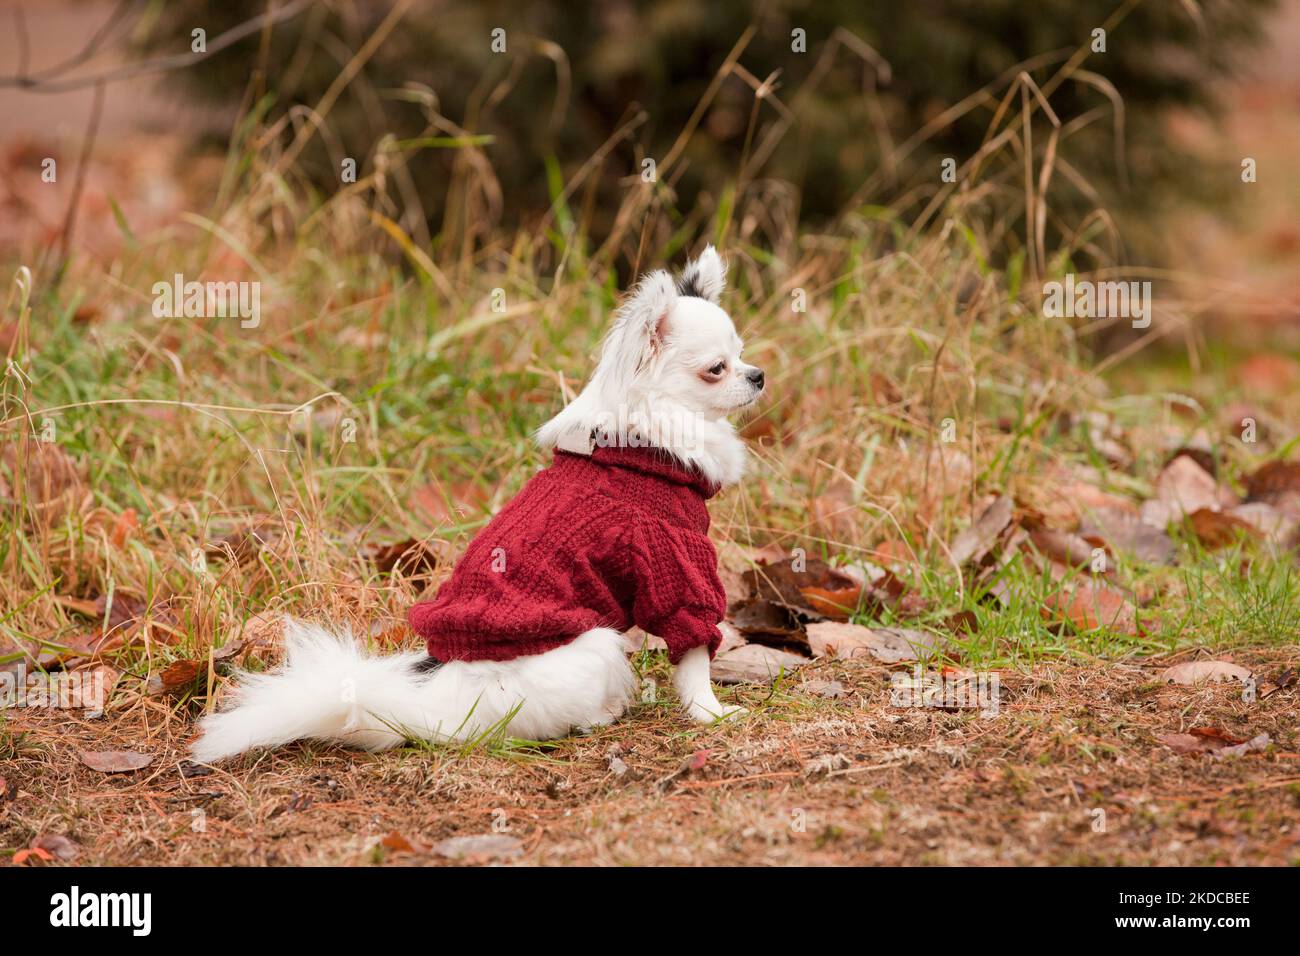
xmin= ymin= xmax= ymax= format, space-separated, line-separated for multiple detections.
xmin=192 ymin=246 xmax=763 ymax=762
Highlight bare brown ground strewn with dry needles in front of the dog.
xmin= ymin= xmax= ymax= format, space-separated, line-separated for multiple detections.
xmin=0 ymin=646 xmax=1300 ymax=866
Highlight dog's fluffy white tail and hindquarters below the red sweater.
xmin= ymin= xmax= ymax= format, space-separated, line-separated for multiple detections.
xmin=192 ymin=620 xmax=636 ymax=763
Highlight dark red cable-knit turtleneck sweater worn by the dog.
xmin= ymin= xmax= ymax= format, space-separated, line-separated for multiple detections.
xmin=410 ymin=447 xmax=727 ymax=663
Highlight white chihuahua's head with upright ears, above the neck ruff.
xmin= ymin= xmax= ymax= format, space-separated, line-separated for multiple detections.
xmin=592 ymin=246 xmax=764 ymax=420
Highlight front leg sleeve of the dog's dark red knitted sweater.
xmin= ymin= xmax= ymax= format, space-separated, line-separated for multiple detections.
xmin=627 ymin=519 xmax=727 ymax=663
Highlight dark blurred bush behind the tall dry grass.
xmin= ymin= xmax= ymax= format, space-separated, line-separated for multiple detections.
xmin=137 ymin=0 xmax=1274 ymax=260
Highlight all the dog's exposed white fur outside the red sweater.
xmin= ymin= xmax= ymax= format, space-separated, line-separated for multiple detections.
xmin=192 ymin=246 xmax=763 ymax=762
